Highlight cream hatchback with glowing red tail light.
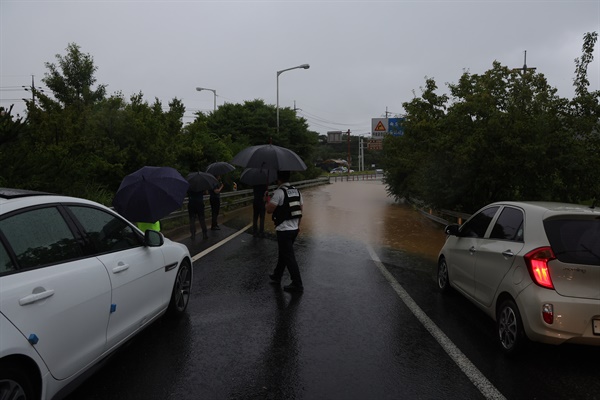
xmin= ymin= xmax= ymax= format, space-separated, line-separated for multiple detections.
xmin=437 ymin=202 xmax=600 ymax=354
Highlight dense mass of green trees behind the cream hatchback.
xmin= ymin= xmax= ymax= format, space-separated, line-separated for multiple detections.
xmin=384 ymin=34 xmax=600 ymax=212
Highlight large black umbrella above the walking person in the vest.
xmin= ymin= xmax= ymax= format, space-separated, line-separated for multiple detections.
xmin=231 ymin=144 xmax=306 ymax=171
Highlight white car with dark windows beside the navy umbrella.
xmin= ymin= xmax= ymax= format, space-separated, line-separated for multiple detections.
xmin=0 ymin=188 xmax=192 ymax=400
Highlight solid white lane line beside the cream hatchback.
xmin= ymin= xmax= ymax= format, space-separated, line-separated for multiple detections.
xmin=367 ymin=245 xmax=506 ymax=400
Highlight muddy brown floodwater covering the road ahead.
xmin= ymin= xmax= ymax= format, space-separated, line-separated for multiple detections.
xmin=258 ymin=180 xmax=446 ymax=259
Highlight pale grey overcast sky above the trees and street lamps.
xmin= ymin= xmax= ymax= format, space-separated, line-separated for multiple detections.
xmin=0 ymin=0 xmax=600 ymax=134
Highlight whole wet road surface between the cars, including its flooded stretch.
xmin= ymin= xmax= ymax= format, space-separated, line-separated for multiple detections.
xmin=69 ymin=181 xmax=600 ymax=400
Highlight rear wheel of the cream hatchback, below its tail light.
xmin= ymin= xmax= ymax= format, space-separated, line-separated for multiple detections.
xmin=496 ymin=300 xmax=527 ymax=354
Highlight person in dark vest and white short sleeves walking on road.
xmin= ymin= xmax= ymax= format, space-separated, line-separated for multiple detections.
xmin=266 ymin=171 xmax=304 ymax=292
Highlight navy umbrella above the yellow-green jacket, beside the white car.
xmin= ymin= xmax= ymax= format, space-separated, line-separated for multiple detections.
xmin=113 ymin=167 xmax=189 ymax=222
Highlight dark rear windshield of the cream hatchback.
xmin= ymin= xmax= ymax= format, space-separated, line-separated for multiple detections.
xmin=544 ymin=219 xmax=600 ymax=265
